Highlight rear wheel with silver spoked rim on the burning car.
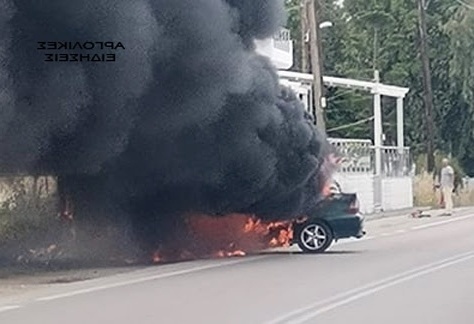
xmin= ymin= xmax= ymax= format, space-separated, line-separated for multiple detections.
xmin=298 ymin=220 xmax=334 ymax=253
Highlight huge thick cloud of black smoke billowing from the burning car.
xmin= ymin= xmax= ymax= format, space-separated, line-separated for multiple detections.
xmin=0 ymin=0 xmax=327 ymax=240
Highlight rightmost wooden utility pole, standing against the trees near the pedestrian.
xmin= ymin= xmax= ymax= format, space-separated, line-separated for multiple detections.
xmin=417 ymin=0 xmax=435 ymax=172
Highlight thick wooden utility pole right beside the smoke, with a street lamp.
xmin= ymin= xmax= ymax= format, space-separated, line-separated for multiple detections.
xmin=307 ymin=0 xmax=326 ymax=134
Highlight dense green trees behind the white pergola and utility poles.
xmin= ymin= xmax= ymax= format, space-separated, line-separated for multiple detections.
xmin=287 ymin=0 xmax=474 ymax=175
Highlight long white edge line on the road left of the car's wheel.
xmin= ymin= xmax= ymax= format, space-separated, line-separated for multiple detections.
xmin=36 ymin=256 xmax=268 ymax=301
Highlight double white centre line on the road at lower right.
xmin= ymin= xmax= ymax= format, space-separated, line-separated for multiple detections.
xmin=265 ymin=251 xmax=474 ymax=324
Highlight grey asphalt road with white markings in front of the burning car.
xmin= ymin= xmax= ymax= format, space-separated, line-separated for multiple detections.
xmin=0 ymin=209 xmax=474 ymax=324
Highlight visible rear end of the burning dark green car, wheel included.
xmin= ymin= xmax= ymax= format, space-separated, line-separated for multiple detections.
xmin=291 ymin=183 xmax=365 ymax=253
